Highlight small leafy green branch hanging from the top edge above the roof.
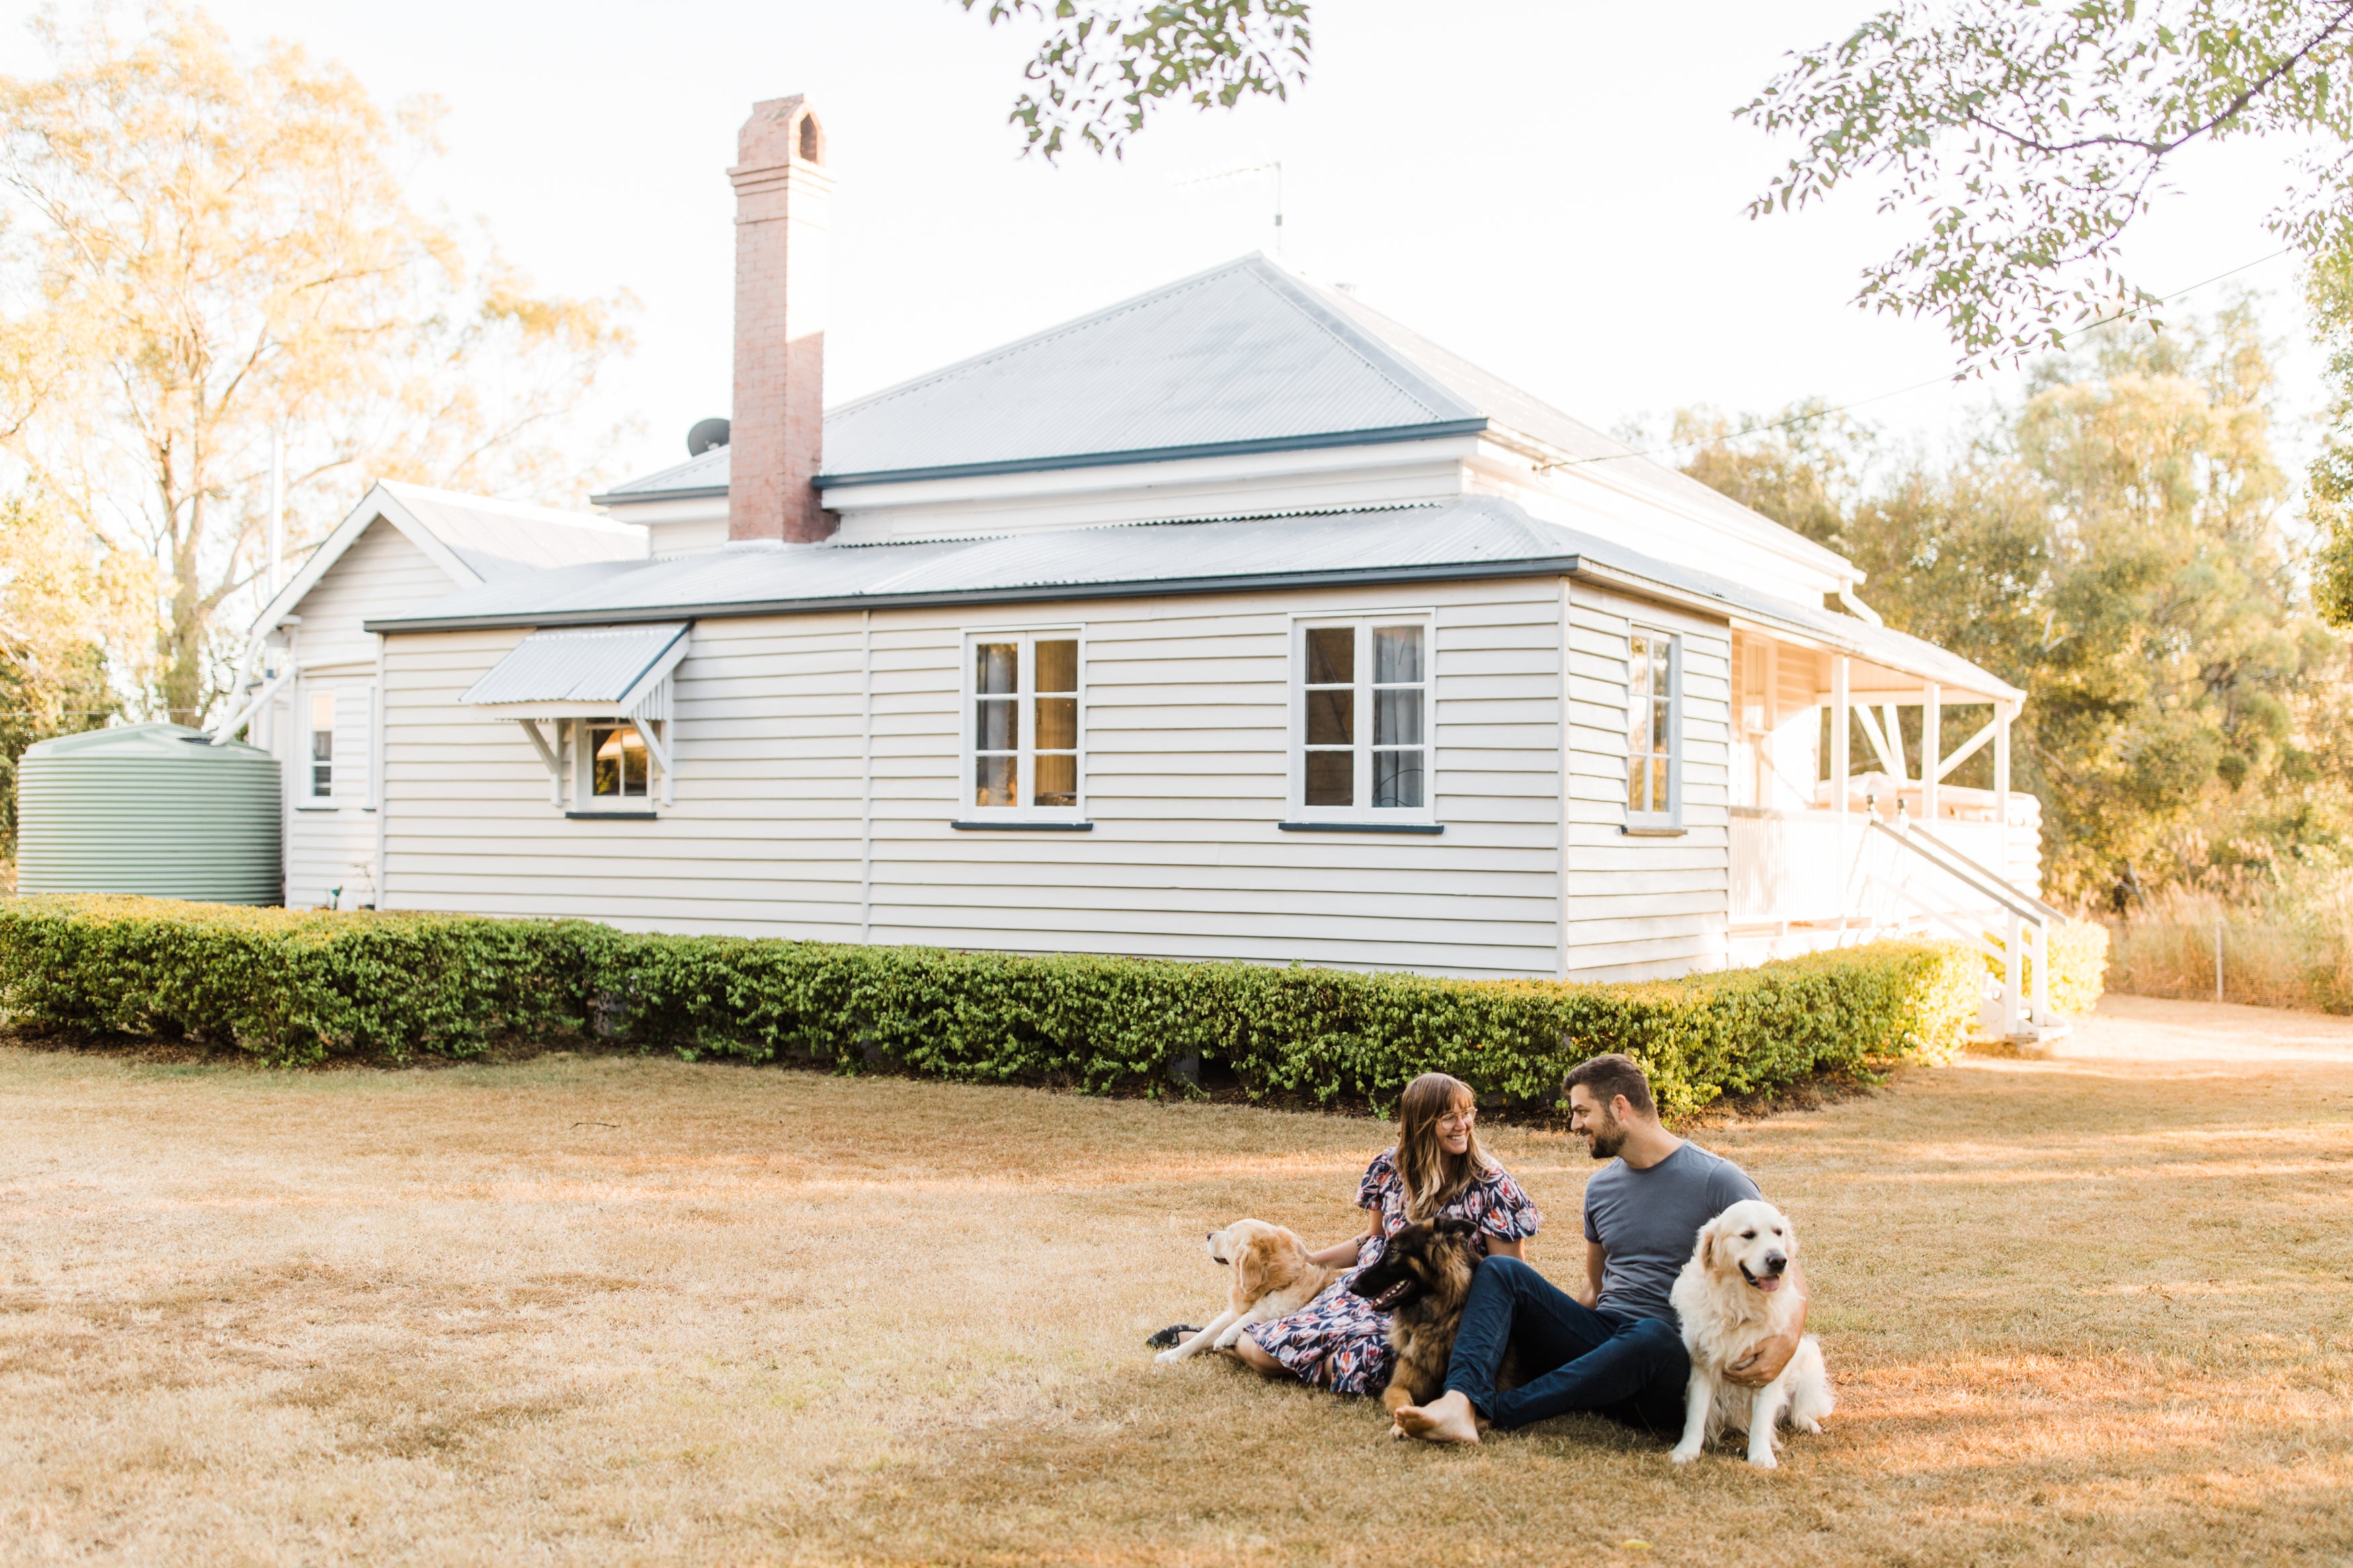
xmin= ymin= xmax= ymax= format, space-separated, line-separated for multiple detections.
xmin=955 ymin=0 xmax=1311 ymax=162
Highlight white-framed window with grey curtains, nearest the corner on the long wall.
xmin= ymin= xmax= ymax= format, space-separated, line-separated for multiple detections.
xmin=1292 ymin=616 xmax=1435 ymax=823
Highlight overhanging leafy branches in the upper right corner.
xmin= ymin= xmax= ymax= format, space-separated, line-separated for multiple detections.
xmin=1739 ymin=0 xmax=2353 ymax=369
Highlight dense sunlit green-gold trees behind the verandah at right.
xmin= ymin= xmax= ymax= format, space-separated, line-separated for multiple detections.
xmin=1689 ymin=301 xmax=2353 ymax=901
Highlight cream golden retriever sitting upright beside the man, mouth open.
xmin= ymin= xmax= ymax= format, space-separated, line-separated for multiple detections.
xmin=1669 ymin=1199 xmax=1831 ymax=1469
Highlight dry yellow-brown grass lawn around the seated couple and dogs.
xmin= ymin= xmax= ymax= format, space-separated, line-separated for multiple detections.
xmin=0 ymin=997 xmax=2353 ymax=1568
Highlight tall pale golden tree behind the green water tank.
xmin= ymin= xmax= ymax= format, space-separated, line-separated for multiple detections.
xmin=0 ymin=9 xmax=629 ymax=722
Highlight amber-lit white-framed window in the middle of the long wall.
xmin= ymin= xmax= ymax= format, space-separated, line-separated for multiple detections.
xmin=963 ymin=630 xmax=1087 ymax=821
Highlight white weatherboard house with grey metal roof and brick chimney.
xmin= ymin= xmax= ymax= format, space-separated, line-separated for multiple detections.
xmin=221 ymin=99 xmax=2050 ymax=1028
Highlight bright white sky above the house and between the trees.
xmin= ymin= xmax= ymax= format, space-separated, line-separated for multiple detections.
xmin=0 ymin=0 xmax=2315 ymax=491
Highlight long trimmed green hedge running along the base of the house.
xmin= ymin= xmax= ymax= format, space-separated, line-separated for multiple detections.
xmin=0 ymin=898 xmax=1984 ymax=1110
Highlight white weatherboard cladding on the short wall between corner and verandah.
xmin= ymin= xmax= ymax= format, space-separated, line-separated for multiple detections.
xmin=1560 ymin=583 xmax=1732 ymax=981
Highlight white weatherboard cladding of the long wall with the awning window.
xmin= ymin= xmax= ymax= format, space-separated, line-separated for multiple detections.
xmin=384 ymin=578 xmax=1581 ymax=976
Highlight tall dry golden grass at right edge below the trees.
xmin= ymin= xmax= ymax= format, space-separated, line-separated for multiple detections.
xmin=2108 ymin=863 xmax=2353 ymax=1014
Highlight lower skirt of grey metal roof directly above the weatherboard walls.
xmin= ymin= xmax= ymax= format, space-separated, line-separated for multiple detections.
xmin=367 ymin=496 xmax=2019 ymax=698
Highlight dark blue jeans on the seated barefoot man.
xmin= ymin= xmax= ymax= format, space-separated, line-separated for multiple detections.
xmin=1447 ymin=1257 xmax=1692 ymax=1436
